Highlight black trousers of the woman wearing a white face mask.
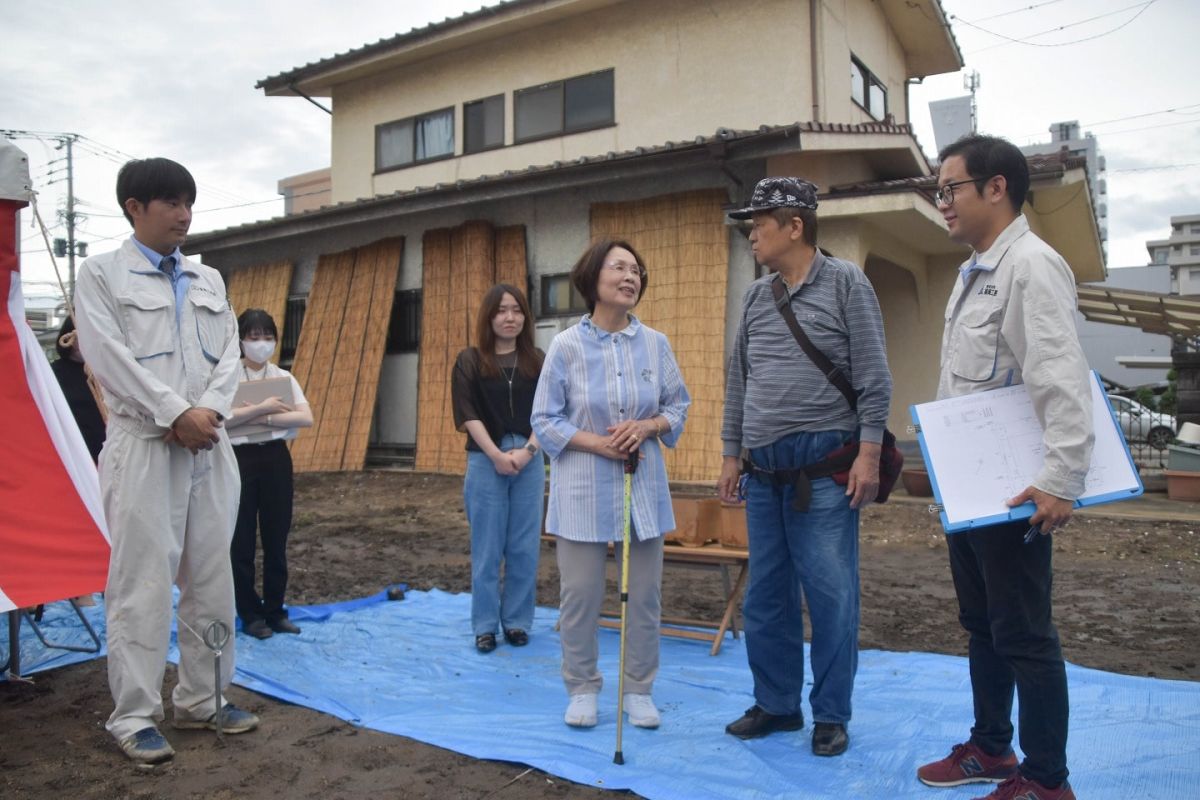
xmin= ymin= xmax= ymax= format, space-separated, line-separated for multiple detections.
xmin=229 ymin=440 xmax=292 ymax=625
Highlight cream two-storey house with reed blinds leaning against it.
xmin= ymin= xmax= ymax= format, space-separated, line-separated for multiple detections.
xmin=187 ymin=0 xmax=1103 ymax=480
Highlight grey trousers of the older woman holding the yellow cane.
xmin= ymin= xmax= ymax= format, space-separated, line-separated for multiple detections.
xmin=556 ymin=536 xmax=662 ymax=694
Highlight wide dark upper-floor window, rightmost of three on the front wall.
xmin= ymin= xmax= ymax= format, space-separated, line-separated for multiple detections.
xmin=512 ymin=70 xmax=614 ymax=142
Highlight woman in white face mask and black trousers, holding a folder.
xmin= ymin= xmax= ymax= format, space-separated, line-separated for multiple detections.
xmin=226 ymin=308 xmax=312 ymax=639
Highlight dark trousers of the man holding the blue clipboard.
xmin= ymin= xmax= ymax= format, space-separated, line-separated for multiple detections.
xmin=947 ymin=521 xmax=1069 ymax=787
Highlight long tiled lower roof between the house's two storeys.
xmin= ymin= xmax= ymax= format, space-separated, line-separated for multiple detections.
xmin=188 ymin=122 xmax=912 ymax=245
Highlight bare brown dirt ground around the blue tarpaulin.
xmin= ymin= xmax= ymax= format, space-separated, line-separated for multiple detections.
xmin=0 ymin=471 xmax=1200 ymax=800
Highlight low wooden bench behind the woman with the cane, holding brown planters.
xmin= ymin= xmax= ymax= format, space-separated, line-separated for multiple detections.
xmin=542 ymin=534 xmax=750 ymax=656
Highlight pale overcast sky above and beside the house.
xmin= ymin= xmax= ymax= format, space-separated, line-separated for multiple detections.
xmin=0 ymin=0 xmax=1200 ymax=292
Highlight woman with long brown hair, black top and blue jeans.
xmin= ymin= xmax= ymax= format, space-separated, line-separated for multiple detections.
xmin=450 ymin=283 xmax=546 ymax=652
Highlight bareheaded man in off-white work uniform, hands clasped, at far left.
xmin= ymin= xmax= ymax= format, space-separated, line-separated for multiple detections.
xmin=74 ymin=158 xmax=258 ymax=764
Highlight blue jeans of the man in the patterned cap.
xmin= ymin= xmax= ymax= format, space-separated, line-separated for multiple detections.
xmin=742 ymin=431 xmax=858 ymax=724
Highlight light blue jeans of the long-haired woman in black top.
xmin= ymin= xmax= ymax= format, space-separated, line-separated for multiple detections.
xmin=462 ymin=433 xmax=546 ymax=636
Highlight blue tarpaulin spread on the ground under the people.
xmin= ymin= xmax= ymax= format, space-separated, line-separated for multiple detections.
xmin=4 ymin=590 xmax=1200 ymax=800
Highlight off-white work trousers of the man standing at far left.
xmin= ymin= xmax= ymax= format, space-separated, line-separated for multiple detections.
xmin=100 ymin=422 xmax=239 ymax=741
